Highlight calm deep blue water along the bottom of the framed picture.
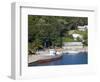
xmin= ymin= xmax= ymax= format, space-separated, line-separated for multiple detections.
xmin=29 ymin=52 xmax=88 ymax=66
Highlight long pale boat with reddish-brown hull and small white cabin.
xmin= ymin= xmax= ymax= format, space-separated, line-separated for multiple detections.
xmin=28 ymin=49 xmax=63 ymax=64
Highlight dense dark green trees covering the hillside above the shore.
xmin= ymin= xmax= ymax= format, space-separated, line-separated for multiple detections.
xmin=28 ymin=15 xmax=88 ymax=53
